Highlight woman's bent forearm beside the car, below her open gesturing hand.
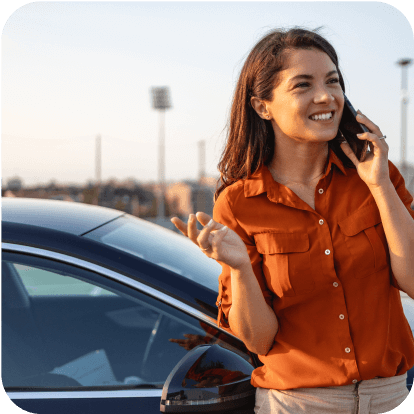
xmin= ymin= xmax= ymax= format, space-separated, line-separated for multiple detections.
xmin=228 ymin=261 xmax=279 ymax=355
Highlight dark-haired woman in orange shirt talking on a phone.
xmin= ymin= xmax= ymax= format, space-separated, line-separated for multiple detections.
xmin=172 ymin=28 xmax=414 ymax=414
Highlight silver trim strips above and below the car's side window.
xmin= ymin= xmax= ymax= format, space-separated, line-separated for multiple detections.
xmin=1 ymin=242 xmax=244 ymax=399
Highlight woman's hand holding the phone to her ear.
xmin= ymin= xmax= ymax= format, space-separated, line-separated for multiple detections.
xmin=341 ymin=111 xmax=390 ymax=189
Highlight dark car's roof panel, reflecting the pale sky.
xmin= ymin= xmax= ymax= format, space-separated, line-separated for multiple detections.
xmin=1 ymin=197 xmax=125 ymax=236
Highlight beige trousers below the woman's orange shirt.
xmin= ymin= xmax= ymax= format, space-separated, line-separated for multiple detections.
xmin=254 ymin=374 xmax=410 ymax=414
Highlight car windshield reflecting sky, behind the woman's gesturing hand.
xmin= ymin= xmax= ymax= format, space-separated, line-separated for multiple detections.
xmin=84 ymin=214 xmax=222 ymax=292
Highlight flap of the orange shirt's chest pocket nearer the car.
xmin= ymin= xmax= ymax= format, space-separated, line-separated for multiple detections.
xmin=254 ymin=233 xmax=309 ymax=254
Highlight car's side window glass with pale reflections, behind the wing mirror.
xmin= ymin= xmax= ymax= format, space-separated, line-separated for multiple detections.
xmin=1 ymin=253 xmax=250 ymax=390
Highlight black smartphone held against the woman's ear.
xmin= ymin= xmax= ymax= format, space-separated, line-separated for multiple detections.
xmin=339 ymin=94 xmax=370 ymax=161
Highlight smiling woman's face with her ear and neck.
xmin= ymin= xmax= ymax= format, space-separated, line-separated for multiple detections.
xmin=250 ymin=49 xmax=344 ymax=192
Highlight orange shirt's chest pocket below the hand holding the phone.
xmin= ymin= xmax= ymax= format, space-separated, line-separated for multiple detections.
xmin=338 ymin=206 xmax=388 ymax=279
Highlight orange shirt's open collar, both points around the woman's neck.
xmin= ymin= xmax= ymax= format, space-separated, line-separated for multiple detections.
xmin=244 ymin=148 xmax=347 ymax=200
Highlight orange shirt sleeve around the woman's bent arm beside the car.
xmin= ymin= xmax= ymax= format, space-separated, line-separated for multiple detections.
xmin=213 ymin=191 xmax=273 ymax=328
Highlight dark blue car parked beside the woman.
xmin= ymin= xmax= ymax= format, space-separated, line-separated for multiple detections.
xmin=1 ymin=198 xmax=414 ymax=414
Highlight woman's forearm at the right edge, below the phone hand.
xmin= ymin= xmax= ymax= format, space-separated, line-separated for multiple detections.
xmin=370 ymin=180 xmax=414 ymax=299
